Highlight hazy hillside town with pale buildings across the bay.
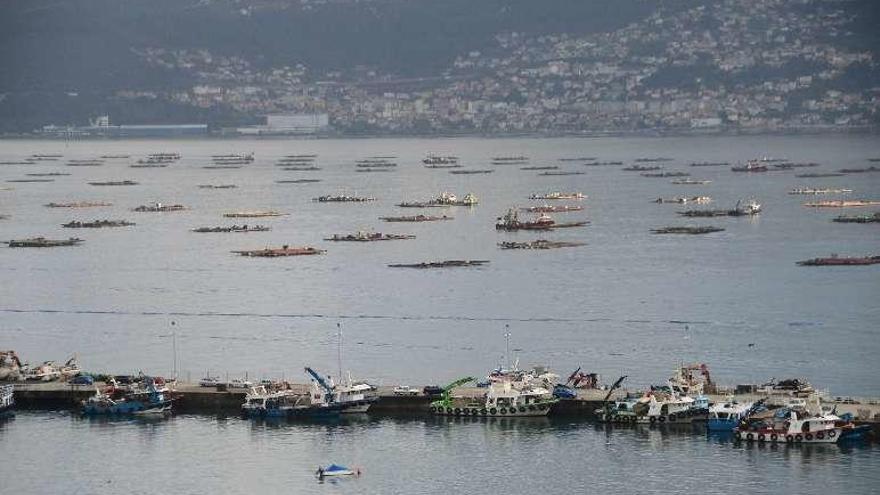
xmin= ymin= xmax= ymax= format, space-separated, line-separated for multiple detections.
xmin=77 ymin=0 xmax=880 ymax=134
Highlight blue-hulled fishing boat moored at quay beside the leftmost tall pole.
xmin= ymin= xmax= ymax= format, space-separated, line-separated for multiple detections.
xmin=82 ymin=376 xmax=173 ymax=416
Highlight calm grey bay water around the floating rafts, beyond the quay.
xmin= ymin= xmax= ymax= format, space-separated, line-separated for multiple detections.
xmin=0 ymin=136 xmax=880 ymax=396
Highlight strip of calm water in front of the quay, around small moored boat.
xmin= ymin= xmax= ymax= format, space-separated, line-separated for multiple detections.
xmin=0 ymin=413 xmax=880 ymax=495
